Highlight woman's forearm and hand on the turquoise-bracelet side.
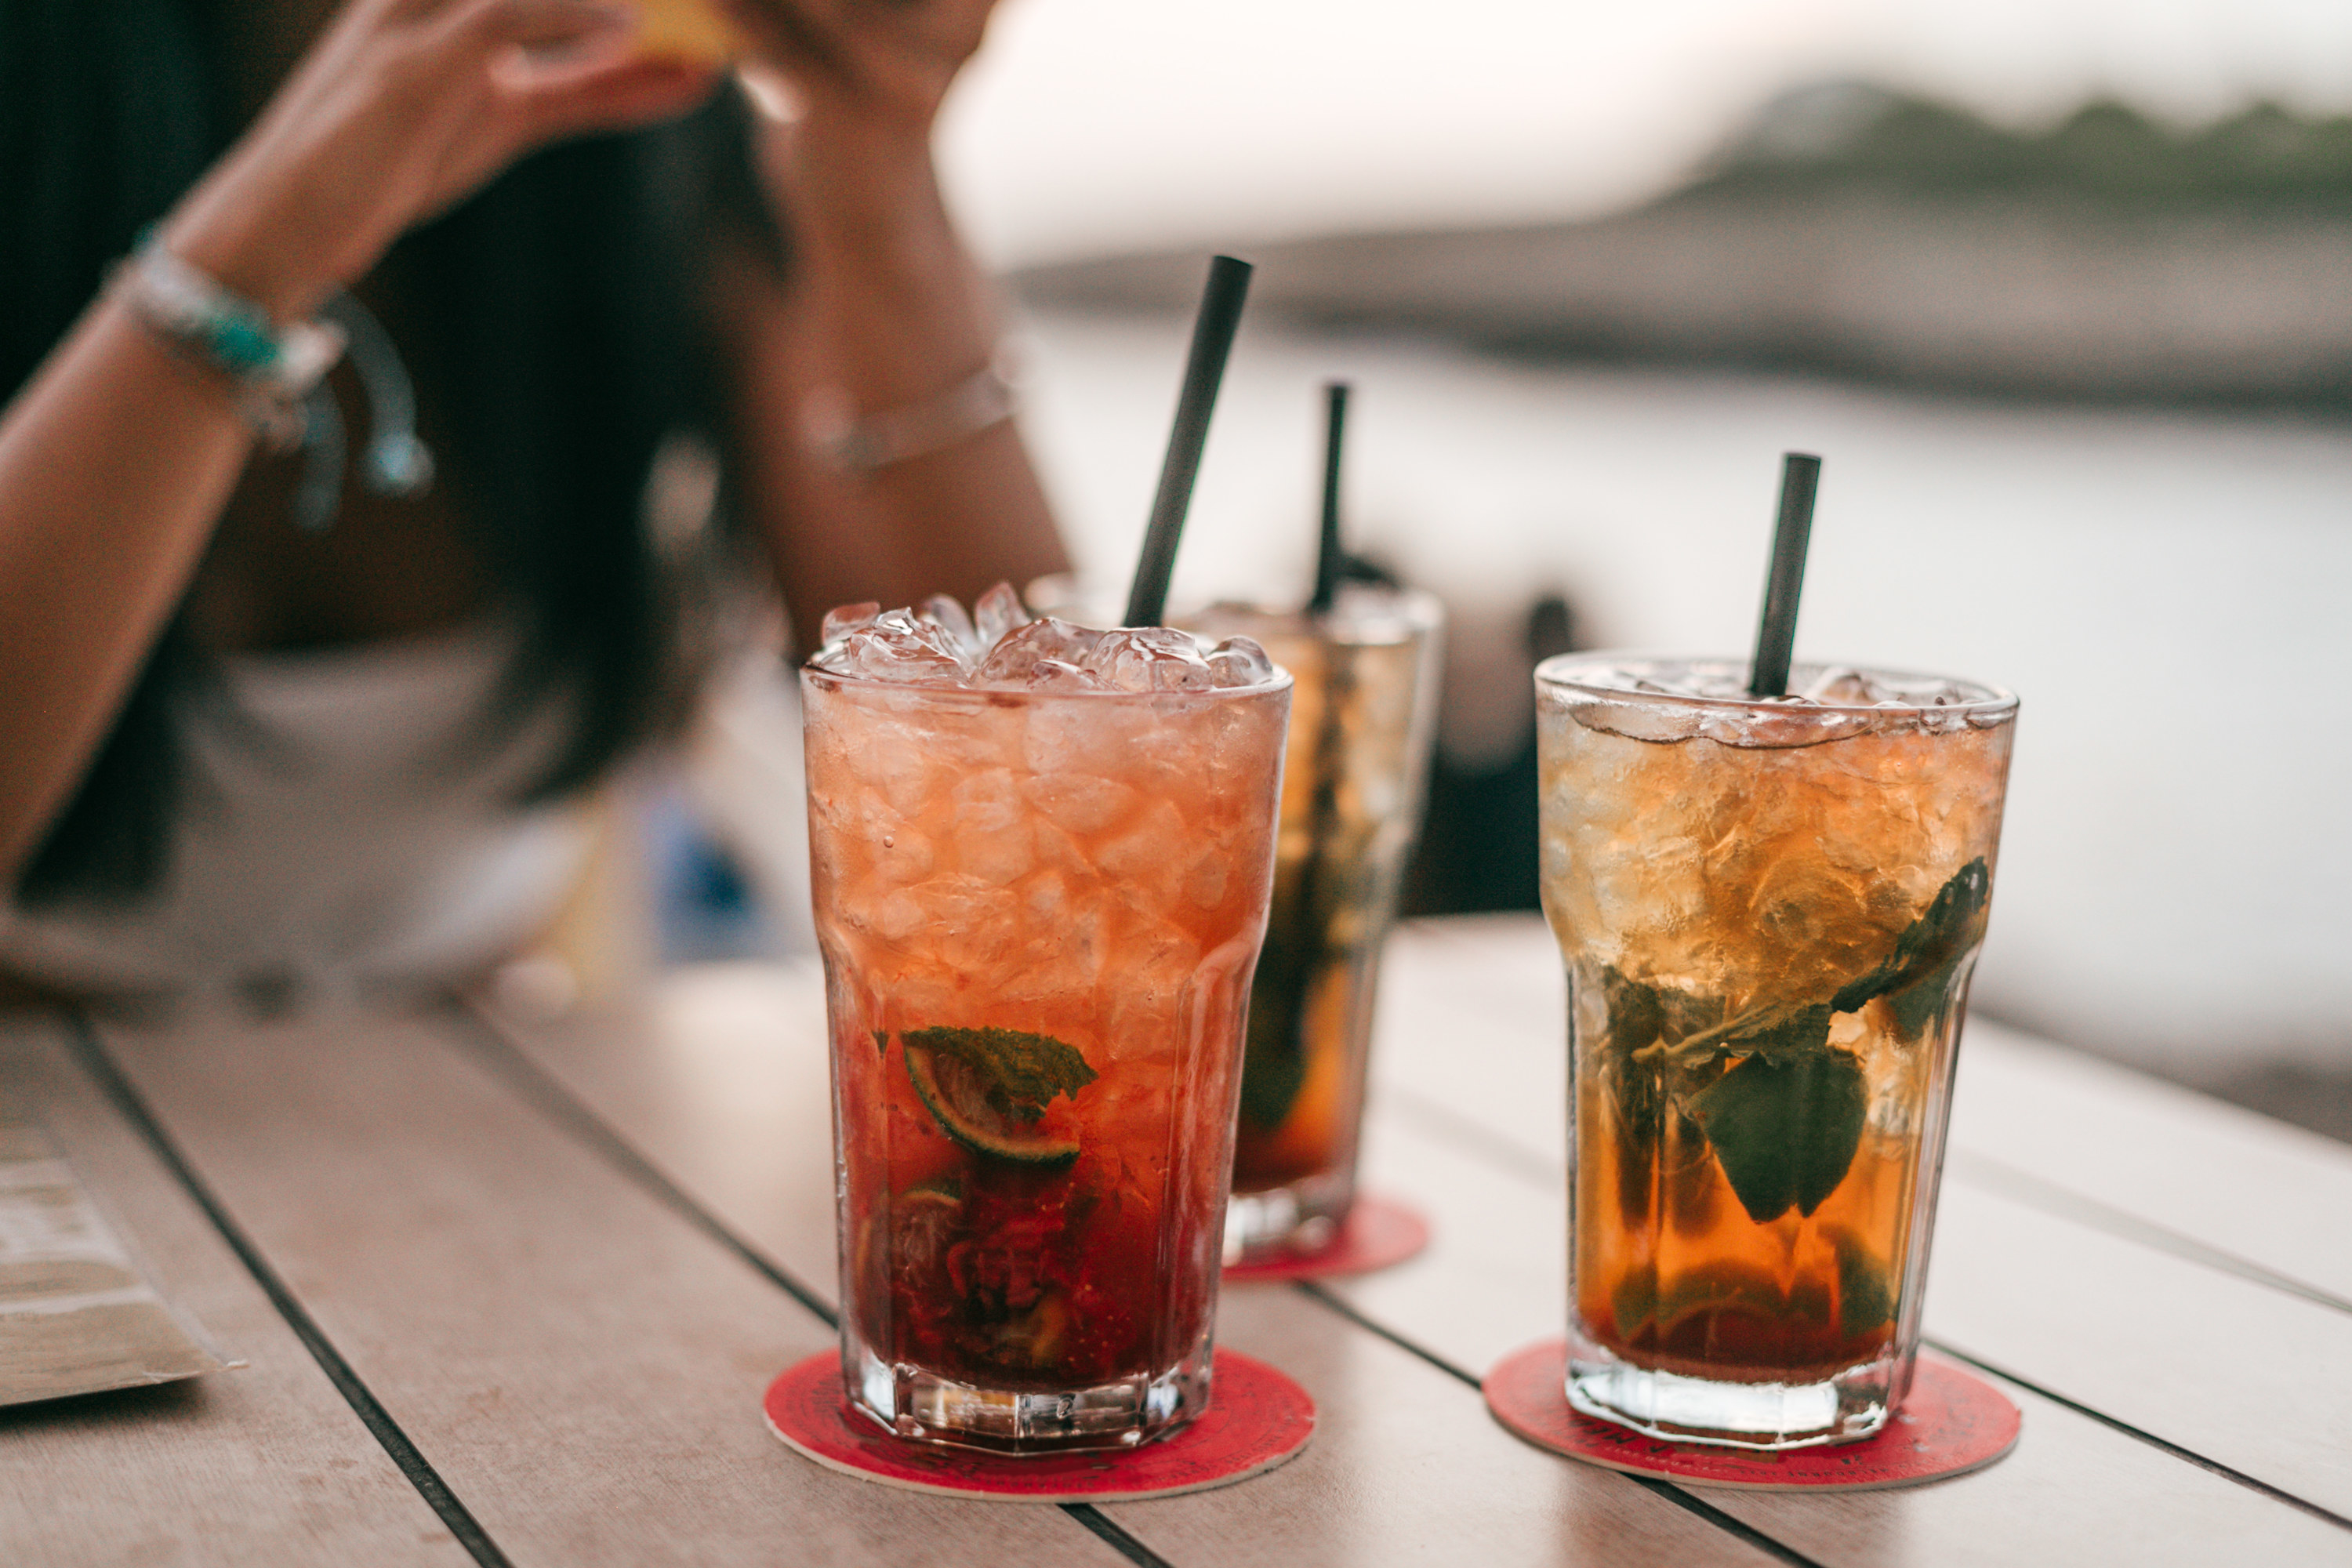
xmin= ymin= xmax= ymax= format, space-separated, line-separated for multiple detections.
xmin=0 ymin=0 xmax=710 ymax=886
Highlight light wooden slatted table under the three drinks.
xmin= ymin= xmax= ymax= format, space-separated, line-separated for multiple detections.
xmin=0 ymin=916 xmax=2352 ymax=1568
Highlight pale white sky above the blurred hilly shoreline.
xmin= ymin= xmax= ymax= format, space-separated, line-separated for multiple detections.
xmin=946 ymin=0 xmax=2352 ymax=263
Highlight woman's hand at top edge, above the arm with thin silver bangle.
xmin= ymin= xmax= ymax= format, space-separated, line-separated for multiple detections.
xmin=724 ymin=0 xmax=995 ymax=136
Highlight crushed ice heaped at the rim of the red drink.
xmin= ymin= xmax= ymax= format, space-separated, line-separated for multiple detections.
xmin=809 ymin=583 xmax=1275 ymax=691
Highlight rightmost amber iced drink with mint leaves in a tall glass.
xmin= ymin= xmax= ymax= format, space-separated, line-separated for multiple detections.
xmin=1536 ymin=654 xmax=2016 ymax=1448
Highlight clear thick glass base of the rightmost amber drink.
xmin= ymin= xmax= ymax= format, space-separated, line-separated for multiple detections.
xmin=1566 ymin=1340 xmax=1898 ymax=1453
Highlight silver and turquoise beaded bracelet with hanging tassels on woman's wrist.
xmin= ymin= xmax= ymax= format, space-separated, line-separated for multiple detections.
xmin=113 ymin=235 xmax=343 ymax=449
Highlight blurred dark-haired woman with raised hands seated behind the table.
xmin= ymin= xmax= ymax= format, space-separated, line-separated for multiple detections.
xmin=0 ymin=0 xmax=1063 ymax=1013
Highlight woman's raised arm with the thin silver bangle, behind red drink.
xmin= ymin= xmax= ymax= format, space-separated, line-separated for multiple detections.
xmin=720 ymin=0 xmax=1065 ymax=644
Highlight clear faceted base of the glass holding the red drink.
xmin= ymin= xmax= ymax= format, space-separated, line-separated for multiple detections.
xmin=842 ymin=1330 xmax=1209 ymax=1453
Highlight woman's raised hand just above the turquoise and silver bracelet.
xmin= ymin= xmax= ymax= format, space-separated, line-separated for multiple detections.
xmin=165 ymin=0 xmax=713 ymax=320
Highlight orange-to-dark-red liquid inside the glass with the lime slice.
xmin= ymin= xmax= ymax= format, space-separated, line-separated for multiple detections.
xmin=804 ymin=675 xmax=1287 ymax=1389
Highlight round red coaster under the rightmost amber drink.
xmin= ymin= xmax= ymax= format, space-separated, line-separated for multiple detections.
xmin=1486 ymin=1340 xmax=2020 ymax=1493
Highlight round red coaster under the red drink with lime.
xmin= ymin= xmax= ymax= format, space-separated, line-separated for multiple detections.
xmin=767 ymin=1349 xmax=1315 ymax=1502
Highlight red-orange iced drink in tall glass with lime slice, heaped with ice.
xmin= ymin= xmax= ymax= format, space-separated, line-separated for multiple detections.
xmin=802 ymin=588 xmax=1291 ymax=1450
